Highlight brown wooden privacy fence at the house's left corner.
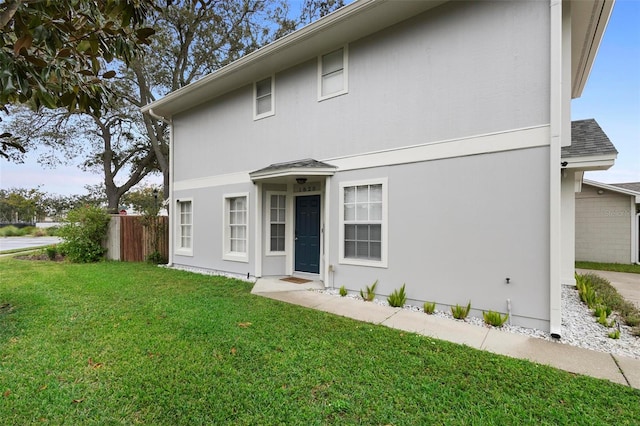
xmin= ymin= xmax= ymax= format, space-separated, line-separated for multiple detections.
xmin=106 ymin=215 xmax=169 ymax=262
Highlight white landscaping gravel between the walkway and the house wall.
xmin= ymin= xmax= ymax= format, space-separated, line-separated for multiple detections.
xmin=319 ymin=286 xmax=640 ymax=359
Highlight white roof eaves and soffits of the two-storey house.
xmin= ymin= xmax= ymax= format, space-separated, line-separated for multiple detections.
xmin=141 ymin=0 xmax=614 ymax=118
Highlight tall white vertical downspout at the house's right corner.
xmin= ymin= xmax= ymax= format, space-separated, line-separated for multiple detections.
xmin=549 ymin=0 xmax=564 ymax=339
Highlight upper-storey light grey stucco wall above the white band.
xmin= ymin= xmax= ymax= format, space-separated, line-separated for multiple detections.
xmin=174 ymin=2 xmax=549 ymax=181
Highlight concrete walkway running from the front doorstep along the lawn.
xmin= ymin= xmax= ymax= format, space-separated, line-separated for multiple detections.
xmin=252 ymin=278 xmax=640 ymax=389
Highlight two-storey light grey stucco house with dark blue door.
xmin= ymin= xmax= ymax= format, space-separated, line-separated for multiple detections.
xmin=143 ymin=0 xmax=615 ymax=335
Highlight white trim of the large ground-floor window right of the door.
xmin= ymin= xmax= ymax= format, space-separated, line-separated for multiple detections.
xmin=338 ymin=178 xmax=389 ymax=268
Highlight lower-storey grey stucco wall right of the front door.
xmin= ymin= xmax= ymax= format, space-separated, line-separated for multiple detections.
xmin=330 ymin=147 xmax=549 ymax=329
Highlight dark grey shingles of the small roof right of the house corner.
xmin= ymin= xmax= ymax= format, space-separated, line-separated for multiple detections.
xmin=562 ymin=118 xmax=618 ymax=158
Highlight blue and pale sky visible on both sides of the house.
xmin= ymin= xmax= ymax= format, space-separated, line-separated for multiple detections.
xmin=0 ymin=0 xmax=640 ymax=195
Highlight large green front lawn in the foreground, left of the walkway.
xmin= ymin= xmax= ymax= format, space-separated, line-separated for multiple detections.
xmin=0 ymin=258 xmax=640 ymax=425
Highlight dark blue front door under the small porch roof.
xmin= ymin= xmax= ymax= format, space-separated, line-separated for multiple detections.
xmin=295 ymin=195 xmax=320 ymax=274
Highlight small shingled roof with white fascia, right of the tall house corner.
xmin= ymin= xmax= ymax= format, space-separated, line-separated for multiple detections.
xmin=561 ymin=118 xmax=618 ymax=170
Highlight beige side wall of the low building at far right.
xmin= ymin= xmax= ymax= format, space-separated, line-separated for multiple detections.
xmin=576 ymin=184 xmax=635 ymax=263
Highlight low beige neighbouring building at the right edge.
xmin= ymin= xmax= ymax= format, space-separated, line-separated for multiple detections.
xmin=576 ymin=180 xmax=640 ymax=263
